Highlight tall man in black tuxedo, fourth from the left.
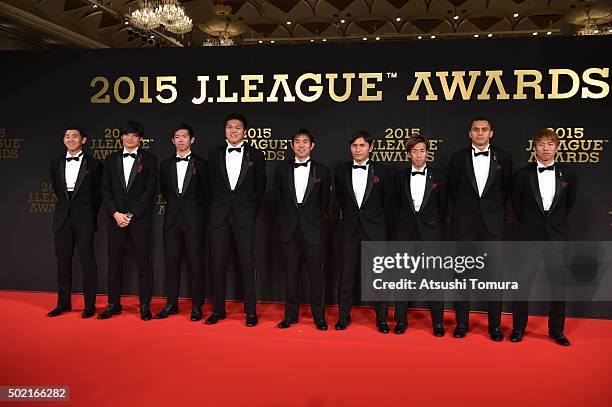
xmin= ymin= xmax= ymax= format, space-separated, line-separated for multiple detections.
xmin=206 ymin=113 xmax=266 ymax=327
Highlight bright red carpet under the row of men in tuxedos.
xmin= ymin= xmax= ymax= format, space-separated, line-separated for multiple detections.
xmin=0 ymin=291 xmax=612 ymax=407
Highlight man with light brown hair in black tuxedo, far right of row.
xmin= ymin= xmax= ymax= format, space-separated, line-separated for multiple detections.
xmin=510 ymin=129 xmax=577 ymax=346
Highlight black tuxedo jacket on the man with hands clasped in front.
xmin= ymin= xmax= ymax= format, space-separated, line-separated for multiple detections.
xmin=102 ymin=148 xmax=157 ymax=228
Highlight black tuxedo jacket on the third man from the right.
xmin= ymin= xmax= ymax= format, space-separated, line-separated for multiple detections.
xmin=393 ymin=165 xmax=448 ymax=241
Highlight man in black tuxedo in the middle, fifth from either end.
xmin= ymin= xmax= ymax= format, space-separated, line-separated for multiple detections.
xmin=274 ymin=129 xmax=330 ymax=331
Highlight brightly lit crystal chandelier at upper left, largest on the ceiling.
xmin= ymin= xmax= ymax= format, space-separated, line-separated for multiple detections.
xmin=128 ymin=0 xmax=193 ymax=34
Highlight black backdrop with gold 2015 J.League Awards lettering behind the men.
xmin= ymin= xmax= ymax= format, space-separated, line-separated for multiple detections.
xmin=0 ymin=37 xmax=612 ymax=317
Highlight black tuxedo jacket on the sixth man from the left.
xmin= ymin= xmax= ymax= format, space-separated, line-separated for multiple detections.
xmin=336 ymin=161 xmax=393 ymax=240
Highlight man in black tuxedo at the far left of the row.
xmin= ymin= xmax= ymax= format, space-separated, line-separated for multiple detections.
xmin=47 ymin=126 xmax=102 ymax=318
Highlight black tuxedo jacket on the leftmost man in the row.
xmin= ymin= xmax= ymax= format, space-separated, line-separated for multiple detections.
xmin=49 ymin=153 xmax=102 ymax=232
